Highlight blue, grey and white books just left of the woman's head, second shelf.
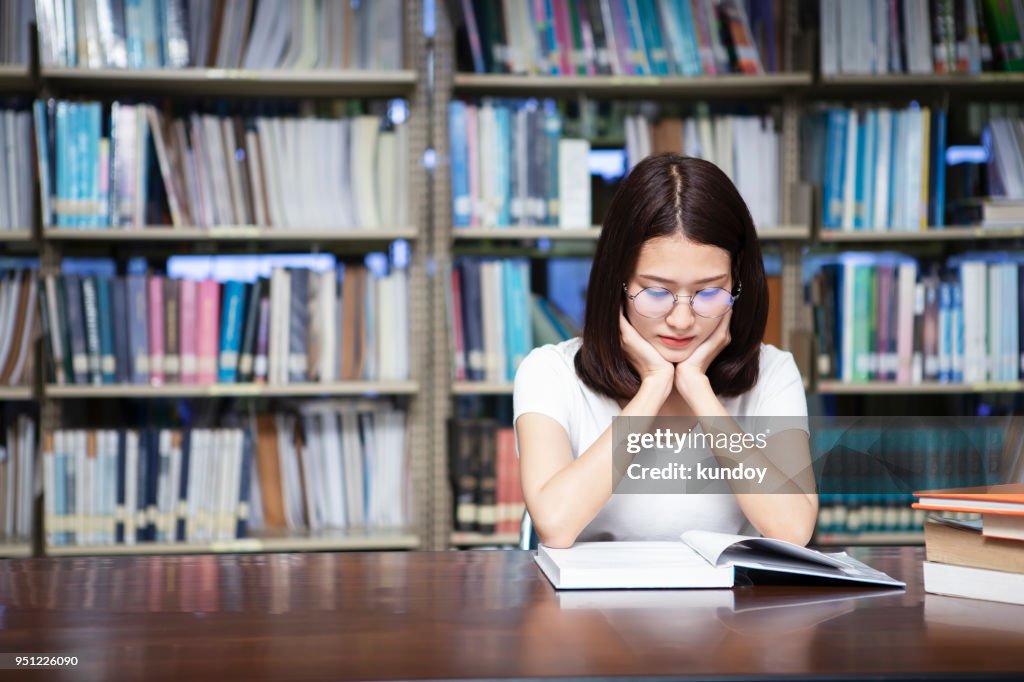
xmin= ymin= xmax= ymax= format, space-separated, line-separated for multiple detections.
xmin=449 ymin=99 xmax=592 ymax=227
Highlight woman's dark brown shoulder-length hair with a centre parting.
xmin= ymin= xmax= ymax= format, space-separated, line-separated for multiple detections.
xmin=575 ymin=154 xmax=768 ymax=400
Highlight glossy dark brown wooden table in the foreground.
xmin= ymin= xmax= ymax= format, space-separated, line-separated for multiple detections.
xmin=0 ymin=548 xmax=1024 ymax=680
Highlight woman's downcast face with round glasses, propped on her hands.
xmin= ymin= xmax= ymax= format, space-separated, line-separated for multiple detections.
xmin=626 ymin=235 xmax=733 ymax=364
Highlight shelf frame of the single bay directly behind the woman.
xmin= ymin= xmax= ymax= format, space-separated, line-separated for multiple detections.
xmin=432 ymin=3 xmax=814 ymax=547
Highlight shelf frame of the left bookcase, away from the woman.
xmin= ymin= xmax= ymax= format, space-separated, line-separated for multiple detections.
xmin=25 ymin=1 xmax=431 ymax=556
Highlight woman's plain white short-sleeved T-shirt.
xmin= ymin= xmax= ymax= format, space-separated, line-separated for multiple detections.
xmin=512 ymin=338 xmax=808 ymax=542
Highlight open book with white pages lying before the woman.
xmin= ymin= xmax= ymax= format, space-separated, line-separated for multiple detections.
xmin=536 ymin=530 xmax=906 ymax=590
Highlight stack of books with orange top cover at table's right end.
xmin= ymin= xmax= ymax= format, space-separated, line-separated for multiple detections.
xmin=913 ymin=483 xmax=1024 ymax=605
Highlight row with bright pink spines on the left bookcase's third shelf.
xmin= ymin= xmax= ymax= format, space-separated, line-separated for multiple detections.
xmin=42 ymin=258 xmax=409 ymax=385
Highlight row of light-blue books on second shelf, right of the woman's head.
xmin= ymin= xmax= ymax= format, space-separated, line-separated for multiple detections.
xmin=805 ymin=106 xmax=946 ymax=231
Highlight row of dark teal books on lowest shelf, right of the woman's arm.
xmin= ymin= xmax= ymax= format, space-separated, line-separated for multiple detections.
xmin=811 ymin=423 xmax=1013 ymax=534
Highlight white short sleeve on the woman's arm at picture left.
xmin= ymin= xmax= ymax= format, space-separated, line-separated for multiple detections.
xmin=512 ymin=345 xmax=578 ymax=440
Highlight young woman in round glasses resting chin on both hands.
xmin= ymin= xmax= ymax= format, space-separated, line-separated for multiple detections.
xmin=513 ymin=154 xmax=817 ymax=547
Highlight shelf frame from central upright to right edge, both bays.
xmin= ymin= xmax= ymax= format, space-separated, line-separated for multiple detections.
xmin=432 ymin=2 xmax=1024 ymax=547
